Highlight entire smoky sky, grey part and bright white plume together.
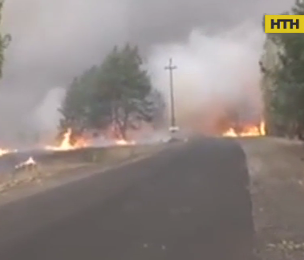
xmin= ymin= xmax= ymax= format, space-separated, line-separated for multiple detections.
xmin=0 ymin=0 xmax=293 ymax=142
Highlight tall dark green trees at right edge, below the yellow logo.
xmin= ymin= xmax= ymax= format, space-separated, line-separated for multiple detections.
xmin=262 ymin=0 xmax=304 ymax=139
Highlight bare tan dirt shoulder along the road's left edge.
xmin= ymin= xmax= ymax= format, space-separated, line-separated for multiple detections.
xmin=0 ymin=145 xmax=164 ymax=207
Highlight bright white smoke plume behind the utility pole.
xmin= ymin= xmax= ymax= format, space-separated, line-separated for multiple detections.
xmin=150 ymin=24 xmax=264 ymax=133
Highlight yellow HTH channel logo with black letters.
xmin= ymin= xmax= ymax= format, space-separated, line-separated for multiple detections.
xmin=265 ymin=15 xmax=304 ymax=33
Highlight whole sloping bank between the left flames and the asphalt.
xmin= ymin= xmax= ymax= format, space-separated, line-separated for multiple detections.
xmin=0 ymin=144 xmax=164 ymax=204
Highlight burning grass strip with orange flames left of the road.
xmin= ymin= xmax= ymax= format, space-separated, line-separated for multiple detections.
xmin=0 ymin=124 xmax=164 ymax=197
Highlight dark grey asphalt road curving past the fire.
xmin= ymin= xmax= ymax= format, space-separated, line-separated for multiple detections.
xmin=0 ymin=139 xmax=254 ymax=260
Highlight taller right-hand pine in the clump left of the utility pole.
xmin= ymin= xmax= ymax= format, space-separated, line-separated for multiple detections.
xmin=101 ymin=44 xmax=152 ymax=138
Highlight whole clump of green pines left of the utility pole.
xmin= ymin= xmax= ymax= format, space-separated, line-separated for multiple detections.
xmin=61 ymin=44 xmax=163 ymax=139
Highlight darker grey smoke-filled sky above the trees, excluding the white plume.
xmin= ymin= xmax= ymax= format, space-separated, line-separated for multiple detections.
xmin=0 ymin=0 xmax=293 ymax=142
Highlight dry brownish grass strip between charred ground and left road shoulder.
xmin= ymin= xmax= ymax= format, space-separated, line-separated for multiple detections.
xmin=0 ymin=145 xmax=163 ymax=194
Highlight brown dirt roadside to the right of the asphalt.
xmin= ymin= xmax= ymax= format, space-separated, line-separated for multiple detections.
xmin=239 ymin=137 xmax=304 ymax=260
